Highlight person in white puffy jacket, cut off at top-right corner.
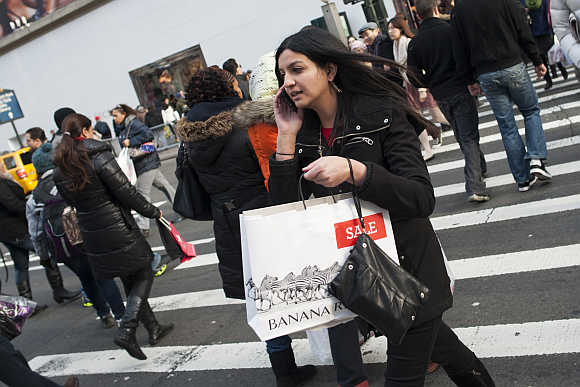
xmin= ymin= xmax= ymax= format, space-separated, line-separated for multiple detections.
xmin=550 ymin=0 xmax=580 ymax=73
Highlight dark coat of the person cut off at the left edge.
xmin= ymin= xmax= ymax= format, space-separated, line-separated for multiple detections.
xmin=0 ymin=177 xmax=28 ymax=242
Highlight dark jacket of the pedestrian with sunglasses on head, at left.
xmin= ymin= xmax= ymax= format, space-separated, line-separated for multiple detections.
xmin=117 ymin=115 xmax=161 ymax=176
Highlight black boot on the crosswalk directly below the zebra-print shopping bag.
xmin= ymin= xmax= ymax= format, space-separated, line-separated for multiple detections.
xmin=269 ymin=348 xmax=316 ymax=387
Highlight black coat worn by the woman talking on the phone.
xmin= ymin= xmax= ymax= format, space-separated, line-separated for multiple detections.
xmin=269 ymin=92 xmax=453 ymax=324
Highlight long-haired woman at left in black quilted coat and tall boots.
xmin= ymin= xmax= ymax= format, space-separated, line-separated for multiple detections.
xmin=54 ymin=113 xmax=173 ymax=360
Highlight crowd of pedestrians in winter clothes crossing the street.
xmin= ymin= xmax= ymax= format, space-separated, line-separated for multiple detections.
xmin=0 ymin=0 xmax=580 ymax=387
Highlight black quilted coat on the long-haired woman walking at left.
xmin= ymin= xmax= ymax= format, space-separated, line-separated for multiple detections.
xmin=54 ymin=139 xmax=160 ymax=279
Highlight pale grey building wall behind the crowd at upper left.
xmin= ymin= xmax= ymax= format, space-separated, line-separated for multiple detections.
xmin=0 ymin=0 xmax=394 ymax=150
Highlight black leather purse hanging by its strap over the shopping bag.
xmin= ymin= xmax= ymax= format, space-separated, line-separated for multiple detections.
xmin=328 ymin=160 xmax=429 ymax=344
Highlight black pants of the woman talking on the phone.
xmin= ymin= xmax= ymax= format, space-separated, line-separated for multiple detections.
xmin=385 ymin=317 xmax=476 ymax=387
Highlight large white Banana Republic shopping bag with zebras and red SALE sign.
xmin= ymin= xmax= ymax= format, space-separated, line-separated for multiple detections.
xmin=240 ymin=195 xmax=398 ymax=340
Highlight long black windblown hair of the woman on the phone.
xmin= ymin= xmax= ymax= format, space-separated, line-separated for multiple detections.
xmin=275 ymin=27 xmax=428 ymax=132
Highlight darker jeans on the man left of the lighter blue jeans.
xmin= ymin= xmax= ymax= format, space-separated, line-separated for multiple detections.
xmin=437 ymin=93 xmax=487 ymax=195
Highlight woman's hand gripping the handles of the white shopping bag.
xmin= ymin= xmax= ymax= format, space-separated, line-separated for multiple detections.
xmin=302 ymin=156 xmax=367 ymax=188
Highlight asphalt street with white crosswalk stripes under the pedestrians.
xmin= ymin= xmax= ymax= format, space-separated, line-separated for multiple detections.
xmin=4 ymin=68 xmax=580 ymax=387
